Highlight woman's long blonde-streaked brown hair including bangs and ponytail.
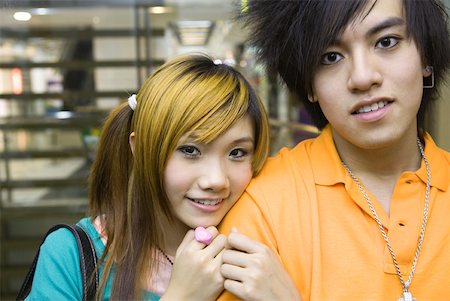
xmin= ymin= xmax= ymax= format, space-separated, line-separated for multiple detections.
xmin=90 ymin=55 xmax=269 ymax=300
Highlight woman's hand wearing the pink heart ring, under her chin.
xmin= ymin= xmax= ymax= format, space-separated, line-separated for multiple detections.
xmin=161 ymin=227 xmax=226 ymax=301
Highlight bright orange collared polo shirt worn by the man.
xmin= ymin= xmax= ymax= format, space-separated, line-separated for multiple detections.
xmin=219 ymin=127 xmax=450 ymax=301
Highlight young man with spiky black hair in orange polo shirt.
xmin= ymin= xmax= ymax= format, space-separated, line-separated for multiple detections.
xmin=221 ymin=0 xmax=450 ymax=300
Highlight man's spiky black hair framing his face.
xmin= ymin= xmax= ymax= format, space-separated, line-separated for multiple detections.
xmin=241 ymin=0 xmax=450 ymax=129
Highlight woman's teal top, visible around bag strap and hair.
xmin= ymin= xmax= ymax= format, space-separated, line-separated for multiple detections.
xmin=26 ymin=218 xmax=160 ymax=301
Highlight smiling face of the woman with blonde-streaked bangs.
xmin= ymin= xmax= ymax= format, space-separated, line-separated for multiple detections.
xmin=164 ymin=116 xmax=255 ymax=228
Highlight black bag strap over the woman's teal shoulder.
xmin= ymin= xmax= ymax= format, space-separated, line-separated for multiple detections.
xmin=16 ymin=224 xmax=98 ymax=301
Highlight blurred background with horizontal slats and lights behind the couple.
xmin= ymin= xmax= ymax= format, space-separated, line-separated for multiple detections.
xmin=0 ymin=0 xmax=450 ymax=300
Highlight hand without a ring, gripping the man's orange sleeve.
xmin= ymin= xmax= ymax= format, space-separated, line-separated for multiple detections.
xmin=221 ymin=229 xmax=300 ymax=301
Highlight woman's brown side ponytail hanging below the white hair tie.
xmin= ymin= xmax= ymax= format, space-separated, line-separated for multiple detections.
xmin=89 ymin=103 xmax=133 ymax=298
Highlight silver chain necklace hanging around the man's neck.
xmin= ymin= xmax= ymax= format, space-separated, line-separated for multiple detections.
xmin=341 ymin=138 xmax=431 ymax=301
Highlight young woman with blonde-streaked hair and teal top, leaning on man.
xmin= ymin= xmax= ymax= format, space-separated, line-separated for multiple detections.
xmin=28 ymin=55 xmax=269 ymax=300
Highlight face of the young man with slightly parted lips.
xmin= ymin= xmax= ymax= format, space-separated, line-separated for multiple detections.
xmin=311 ymin=0 xmax=430 ymax=149
